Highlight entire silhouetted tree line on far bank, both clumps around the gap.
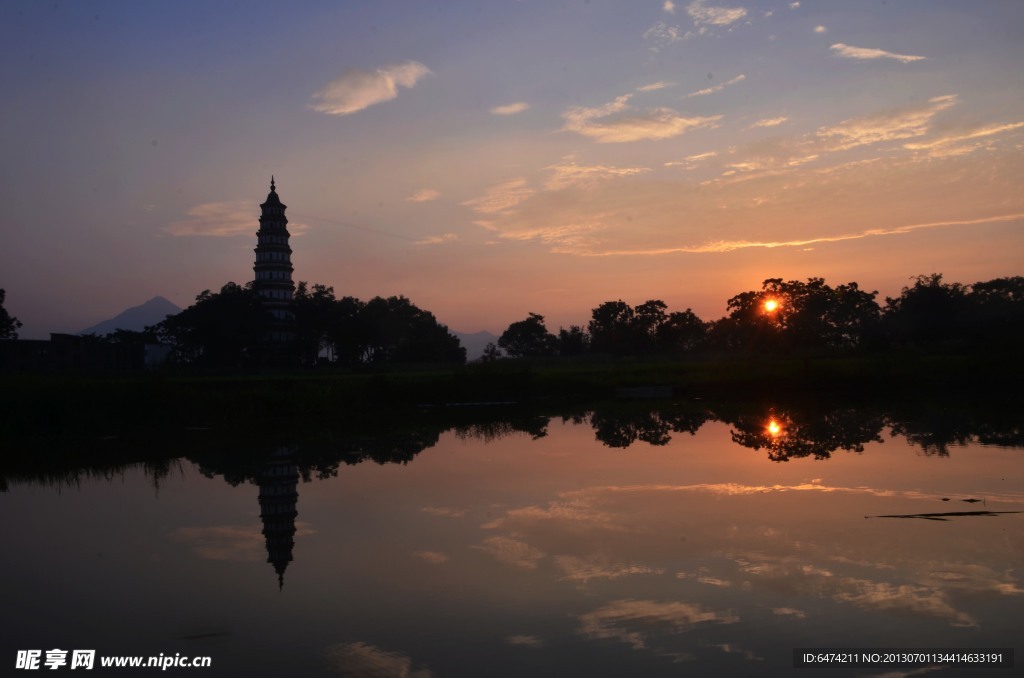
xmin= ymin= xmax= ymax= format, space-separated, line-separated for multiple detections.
xmin=0 ymin=273 xmax=1024 ymax=368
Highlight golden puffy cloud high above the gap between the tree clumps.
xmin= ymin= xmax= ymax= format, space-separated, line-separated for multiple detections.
xmin=562 ymin=94 xmax=722 ymax=143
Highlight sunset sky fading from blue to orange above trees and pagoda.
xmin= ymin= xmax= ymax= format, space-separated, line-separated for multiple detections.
xmin=0 ymin=0 xmax=1024 ymax=338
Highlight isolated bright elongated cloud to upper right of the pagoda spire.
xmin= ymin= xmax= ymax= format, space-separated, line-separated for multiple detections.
xmin=309 ymin=61 xmax=431 ymax=116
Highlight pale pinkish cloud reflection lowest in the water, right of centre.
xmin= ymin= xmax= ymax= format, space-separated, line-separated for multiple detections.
xmin=580 ymin=600 xmax=739 ymax=649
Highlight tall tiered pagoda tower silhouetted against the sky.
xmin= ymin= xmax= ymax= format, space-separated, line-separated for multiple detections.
xmin=253 ymin=176 xmax=295 ymax=343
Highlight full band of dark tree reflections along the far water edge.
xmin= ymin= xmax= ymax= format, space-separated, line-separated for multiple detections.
xmin=0 ymin=399 xmax=1024 ymax=492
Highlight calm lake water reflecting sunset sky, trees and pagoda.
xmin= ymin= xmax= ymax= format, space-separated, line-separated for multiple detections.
xmin=0 ymin=401 xmax=1024 ymax=677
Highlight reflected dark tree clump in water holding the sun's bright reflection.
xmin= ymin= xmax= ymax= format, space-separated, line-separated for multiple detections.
xmin=724 ymin=409 xmax=885 ymax=462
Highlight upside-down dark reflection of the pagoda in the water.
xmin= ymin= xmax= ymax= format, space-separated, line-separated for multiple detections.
xmin=259 ymin=447 xmax=299 ymax=589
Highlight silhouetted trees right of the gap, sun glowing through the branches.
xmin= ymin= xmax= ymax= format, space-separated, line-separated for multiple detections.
xmin=483 ymin=273 xmax=1024 ymax=361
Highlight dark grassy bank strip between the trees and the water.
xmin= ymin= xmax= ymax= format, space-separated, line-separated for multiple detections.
xmin=0 ymin=353 xmax=1024 ymax=437
